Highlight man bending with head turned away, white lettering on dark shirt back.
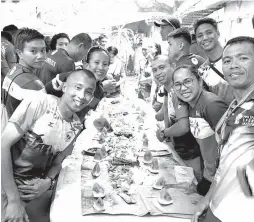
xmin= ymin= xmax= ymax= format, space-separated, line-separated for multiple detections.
xmin=39 ymin=33 xmax=92 ymax=85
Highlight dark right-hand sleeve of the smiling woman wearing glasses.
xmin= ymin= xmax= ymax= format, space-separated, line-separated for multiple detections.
xmin=204 ymin=100 xmax=228 ymax=130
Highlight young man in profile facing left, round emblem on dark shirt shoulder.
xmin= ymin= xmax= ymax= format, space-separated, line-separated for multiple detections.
xmin=168 ymin=28 xmax=205 ymax=68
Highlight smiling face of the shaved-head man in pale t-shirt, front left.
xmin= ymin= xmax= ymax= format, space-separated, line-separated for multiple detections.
xmin=63 ymin=73 xmax=96 ymax=113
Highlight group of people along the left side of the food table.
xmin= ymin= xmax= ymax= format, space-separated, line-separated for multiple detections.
xmin=1 ymin=25 xmax=126 ymax=222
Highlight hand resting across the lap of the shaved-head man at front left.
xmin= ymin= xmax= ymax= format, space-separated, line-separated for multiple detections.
xmin=18 ymin=178 xmax=51 ymax=201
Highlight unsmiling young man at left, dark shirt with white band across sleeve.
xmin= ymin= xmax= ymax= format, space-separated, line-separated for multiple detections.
xmin=2 ymin=28 xmax=46 ymax=116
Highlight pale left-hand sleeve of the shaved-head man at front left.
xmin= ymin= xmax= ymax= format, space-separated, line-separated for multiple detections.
xmin=9 ymin=94 xmax=48 ymax=132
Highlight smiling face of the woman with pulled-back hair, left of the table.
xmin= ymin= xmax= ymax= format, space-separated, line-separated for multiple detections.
xmin=88 ymin=51 xmax=109 ymax=81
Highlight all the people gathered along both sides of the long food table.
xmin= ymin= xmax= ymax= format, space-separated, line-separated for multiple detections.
xmin=1 ymin=14 xmax=254 ymax=222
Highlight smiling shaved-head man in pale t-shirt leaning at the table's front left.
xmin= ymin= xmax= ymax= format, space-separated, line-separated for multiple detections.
xmin=1 ymin=70 xmax=96 ymax=222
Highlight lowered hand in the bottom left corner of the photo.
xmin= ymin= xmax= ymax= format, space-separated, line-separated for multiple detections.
xmin=2 ymin=201 xmax=29 ymax=222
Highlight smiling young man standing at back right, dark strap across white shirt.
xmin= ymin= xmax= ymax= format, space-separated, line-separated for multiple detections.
xmin=194 ymin=18 xmax=234 ymax=103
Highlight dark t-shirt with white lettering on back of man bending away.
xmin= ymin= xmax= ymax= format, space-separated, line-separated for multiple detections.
xmin=39 ymin=49 xmax=75 ymax=85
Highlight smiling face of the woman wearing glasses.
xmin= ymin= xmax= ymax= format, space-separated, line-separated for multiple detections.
xmin=174 ymin=68 xmax=202 ymax=102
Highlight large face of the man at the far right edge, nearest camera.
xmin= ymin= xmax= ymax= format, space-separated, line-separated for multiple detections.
xmin=222 ymin=42 xmax=254 ymax=89
